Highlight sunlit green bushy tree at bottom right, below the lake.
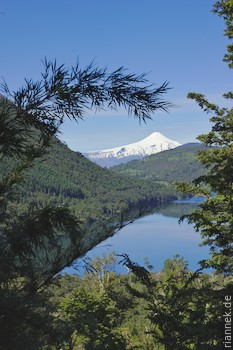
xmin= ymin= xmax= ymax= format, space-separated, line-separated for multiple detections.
xmin=122 ymin=256 xmax=222 ymax=350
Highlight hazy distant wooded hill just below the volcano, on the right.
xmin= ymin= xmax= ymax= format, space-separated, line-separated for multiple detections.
xmin=111 ymin=143 xmax=206 ymax=183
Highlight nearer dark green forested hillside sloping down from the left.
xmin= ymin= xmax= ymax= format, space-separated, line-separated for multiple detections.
xmin=0 ymin=138 xmax=175 ymax=219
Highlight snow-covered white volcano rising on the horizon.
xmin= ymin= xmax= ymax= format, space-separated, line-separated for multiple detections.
xmin=84 ymin=132 xmax=181 ymax=167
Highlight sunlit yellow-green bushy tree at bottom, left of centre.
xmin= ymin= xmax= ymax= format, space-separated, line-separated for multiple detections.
xmin=45 ymin=254 xmax=135 ymax=350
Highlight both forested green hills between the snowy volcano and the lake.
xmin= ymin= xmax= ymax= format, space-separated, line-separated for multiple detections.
xmin=0 ymin=134 xmax=208 ymax=222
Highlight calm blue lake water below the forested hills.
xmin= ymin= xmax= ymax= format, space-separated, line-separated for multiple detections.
xmin=66 ymin=199 xmax=209 ymax=273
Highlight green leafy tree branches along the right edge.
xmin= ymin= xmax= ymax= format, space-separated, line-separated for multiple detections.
xmin=178 ymin=0 xmax=233 ymax=274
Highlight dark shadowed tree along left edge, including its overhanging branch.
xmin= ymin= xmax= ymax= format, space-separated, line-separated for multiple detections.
xmin=0 ymin=60 xmax=170 ymax=349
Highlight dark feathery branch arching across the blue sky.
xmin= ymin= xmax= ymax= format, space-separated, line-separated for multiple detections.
xmin=2 ymin=58 xmax=171 ymax=125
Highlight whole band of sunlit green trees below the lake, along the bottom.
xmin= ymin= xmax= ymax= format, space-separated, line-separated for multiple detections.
xmin=7 ymin=253 xmax=223 ymax=350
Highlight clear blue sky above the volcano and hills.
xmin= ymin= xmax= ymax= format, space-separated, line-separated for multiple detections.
xmin=0 ymin=0 xmax=231 ymax=152
